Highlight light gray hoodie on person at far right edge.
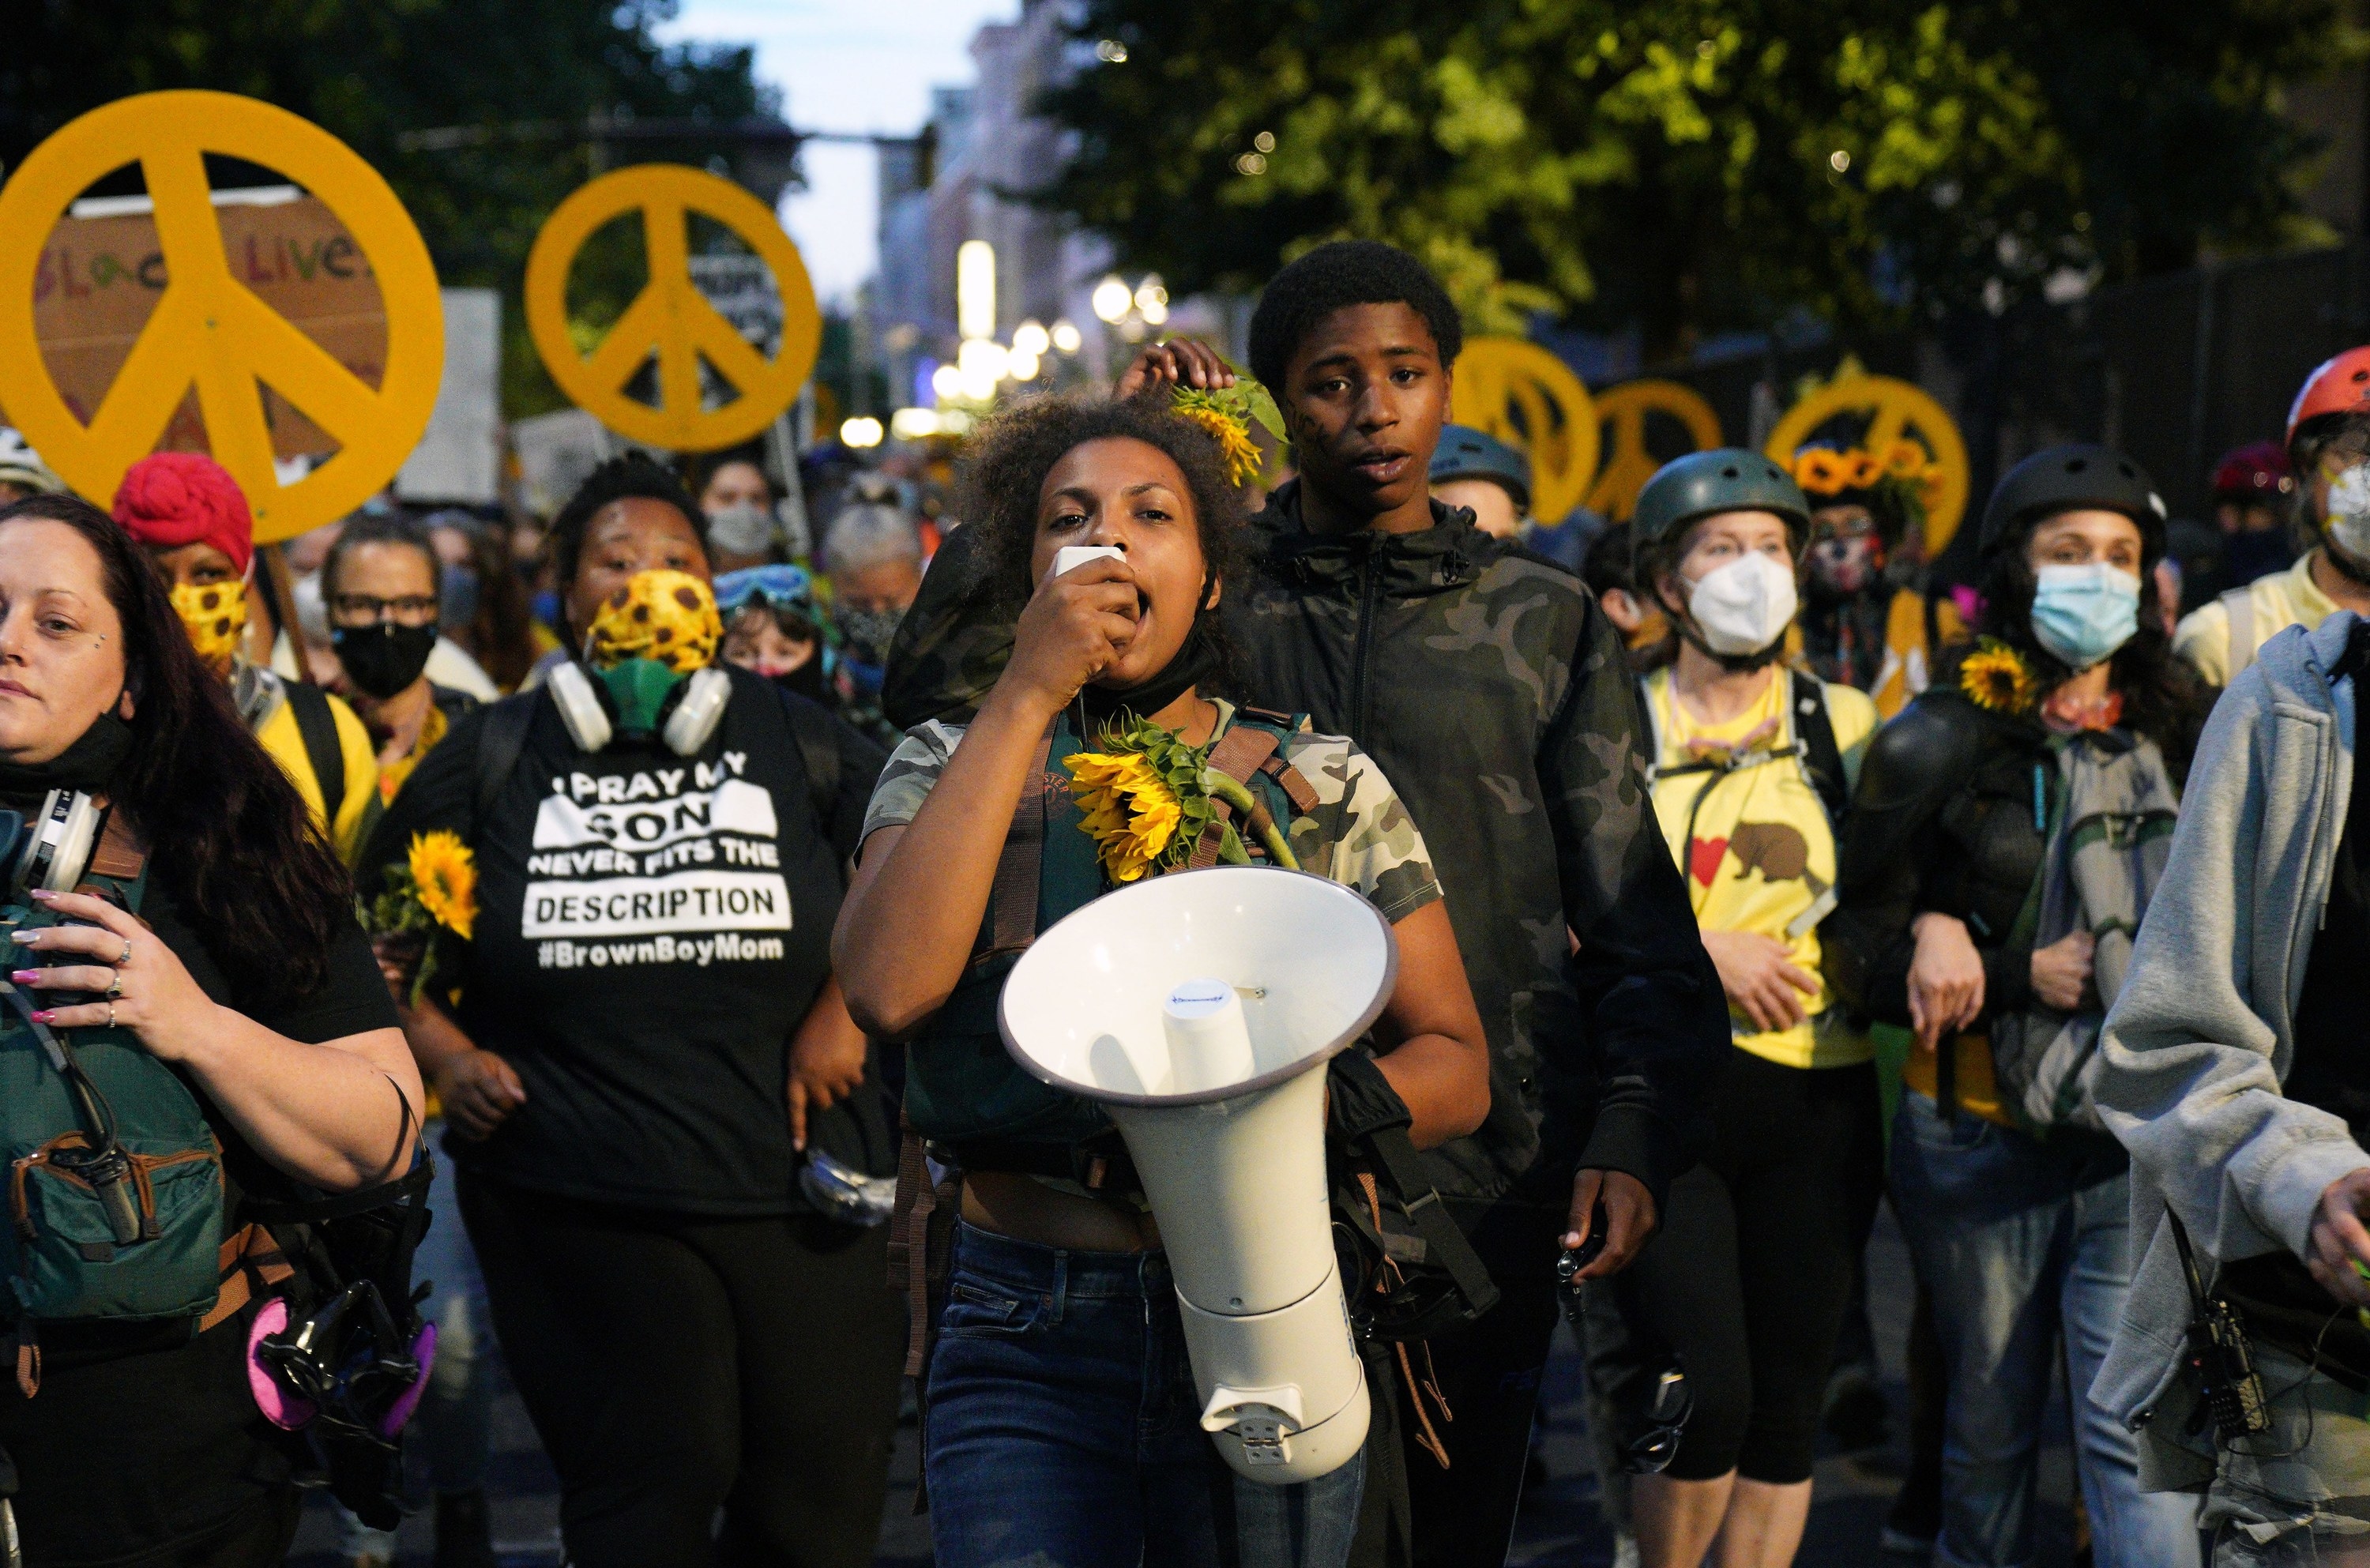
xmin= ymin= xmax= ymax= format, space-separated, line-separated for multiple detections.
xmin=2090 ymin=611 xmax=2370 ymax=1490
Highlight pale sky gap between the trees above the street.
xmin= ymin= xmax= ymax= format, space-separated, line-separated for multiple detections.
xmin=659 ymin=0 xmax=1019 ymax=303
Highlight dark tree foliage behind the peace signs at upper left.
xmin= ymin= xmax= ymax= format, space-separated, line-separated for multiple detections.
xmin=0 ymin=0 xmax=777 ymax=415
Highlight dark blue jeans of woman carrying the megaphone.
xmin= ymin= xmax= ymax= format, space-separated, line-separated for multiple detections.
xmin=924 ymin=1224 xmax=1365 ymax=1568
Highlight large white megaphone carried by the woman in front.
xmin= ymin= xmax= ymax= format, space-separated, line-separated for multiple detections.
xmin=1000 ymin=867 xmax=1398 ymax=1485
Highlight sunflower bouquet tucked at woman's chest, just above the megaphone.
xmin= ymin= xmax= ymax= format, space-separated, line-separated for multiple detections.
xmin=1064 ymin=720 xmax=1299 ymax=883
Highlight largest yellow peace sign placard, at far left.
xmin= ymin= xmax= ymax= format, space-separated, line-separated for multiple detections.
xmin=0 ymin=92 xmax=443 ymax=545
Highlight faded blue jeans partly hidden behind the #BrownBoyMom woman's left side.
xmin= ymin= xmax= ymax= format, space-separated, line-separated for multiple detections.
xmin=337 ymin=1120 xmax=493 ymax=1561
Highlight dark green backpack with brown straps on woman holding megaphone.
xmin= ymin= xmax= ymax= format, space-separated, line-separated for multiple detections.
xmin=905 ymin=709 xmax=1315 ymax=1186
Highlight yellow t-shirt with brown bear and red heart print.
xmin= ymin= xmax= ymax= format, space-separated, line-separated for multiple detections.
xmin=1645 ymin=668 xmax=1877 ymax=1068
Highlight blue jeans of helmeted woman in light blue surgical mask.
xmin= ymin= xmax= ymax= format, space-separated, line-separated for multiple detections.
xmin=1891 ymin=1092 xmax=2199 ymax=1568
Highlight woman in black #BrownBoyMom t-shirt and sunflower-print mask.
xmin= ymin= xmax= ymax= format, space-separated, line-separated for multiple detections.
xmin=363 ymin=460 xmax=903 ymax=1568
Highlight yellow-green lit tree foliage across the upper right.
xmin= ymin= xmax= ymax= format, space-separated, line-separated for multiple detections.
xmin=1038 ymin=0 xmax=2356 ymax=355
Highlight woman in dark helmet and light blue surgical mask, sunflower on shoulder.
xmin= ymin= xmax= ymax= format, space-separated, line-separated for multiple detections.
xmin=1827 ymin=446 xmax=2197 ymax=1568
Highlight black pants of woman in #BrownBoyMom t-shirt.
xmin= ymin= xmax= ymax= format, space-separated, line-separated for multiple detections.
xmin=460 ymin=1170 xmax=905 ymax=1568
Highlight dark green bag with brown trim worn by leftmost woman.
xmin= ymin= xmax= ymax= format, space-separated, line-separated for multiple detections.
xmin=0 ymin=819 xmax=223 ymax=1397
